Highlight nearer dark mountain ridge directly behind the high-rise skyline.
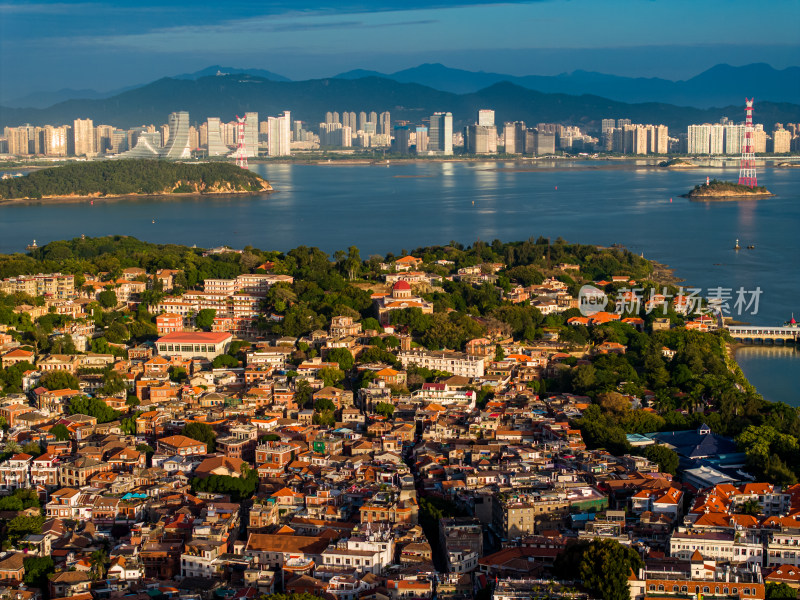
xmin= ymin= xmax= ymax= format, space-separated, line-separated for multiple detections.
xmin=0 ymin=75 xmax=800 ymax=130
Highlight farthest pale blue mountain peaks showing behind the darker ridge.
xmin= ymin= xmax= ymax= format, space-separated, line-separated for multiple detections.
xmin=2 ymin=63 xmax=800 ymax=108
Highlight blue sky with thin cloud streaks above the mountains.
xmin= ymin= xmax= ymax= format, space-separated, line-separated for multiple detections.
xmin=0 ymin=0 xmax=800 ymax=98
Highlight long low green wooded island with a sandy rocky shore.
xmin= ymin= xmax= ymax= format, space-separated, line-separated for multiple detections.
xmin=0 ymin=159 xmax=272 ymax=201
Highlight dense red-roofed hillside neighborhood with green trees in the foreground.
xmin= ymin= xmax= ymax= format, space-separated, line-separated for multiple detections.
xmin=0 ymin=238 xmax=800 ymax=600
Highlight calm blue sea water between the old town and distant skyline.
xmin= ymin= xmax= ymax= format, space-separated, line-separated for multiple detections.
xmin=0 ymin=161 xmax=800 ymax=403
